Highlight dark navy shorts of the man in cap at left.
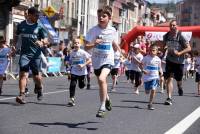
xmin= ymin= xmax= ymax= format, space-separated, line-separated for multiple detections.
xmin=19 ymin=55 xmax=42 ymax=75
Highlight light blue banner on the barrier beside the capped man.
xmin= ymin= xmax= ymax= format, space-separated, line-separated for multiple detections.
xmin=47 ymin=57 xmax=62 ymax=73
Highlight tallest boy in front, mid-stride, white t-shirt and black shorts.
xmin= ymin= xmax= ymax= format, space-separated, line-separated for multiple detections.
xmin=85 ymin=6 xmax=119 ymax=118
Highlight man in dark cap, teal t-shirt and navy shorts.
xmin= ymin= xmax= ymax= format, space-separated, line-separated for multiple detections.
xmin=16 ymin=7 xmax=48 ymax=104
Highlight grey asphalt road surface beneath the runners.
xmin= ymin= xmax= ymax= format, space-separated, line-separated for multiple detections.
xmin=0 ymin=77 xmax=200 ymax=134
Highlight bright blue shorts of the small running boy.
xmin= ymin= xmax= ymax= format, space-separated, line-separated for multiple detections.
xmin=144 ymin=79 xmax=159 ymax=90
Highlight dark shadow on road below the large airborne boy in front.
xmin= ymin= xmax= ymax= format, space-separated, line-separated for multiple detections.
xmin=29 ymin=121 xmax=99 ymax=130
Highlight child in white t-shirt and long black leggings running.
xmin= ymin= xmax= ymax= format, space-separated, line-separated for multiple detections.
xmin=68 ymin=38 xmax=91 ymax=106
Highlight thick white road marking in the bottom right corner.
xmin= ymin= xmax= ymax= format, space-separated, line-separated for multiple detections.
xmin=165 ymin=107 xmax=200 ymax=134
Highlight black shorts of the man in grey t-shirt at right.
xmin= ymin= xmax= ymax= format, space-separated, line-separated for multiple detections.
xmin=165 ymin=60 xmax=184 ymax=81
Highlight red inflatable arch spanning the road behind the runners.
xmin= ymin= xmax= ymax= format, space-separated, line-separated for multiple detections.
xmin=121 ymin=26 xmax=200 ymax=52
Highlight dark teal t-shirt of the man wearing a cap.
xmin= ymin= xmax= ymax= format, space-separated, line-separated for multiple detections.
xmin=17 ymin=20 xmax=47 ymax=58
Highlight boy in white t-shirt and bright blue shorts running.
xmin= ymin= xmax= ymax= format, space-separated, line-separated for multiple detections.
xmin=141 ymin=45 xmax=163 ymax=110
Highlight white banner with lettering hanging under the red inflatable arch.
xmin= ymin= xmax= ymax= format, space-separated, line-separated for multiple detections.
xmin=145 ymin=32 xmax=192 ymax=41
